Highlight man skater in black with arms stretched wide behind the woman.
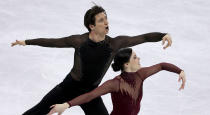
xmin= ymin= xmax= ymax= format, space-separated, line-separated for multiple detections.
xmin=12 ymin=5 xmax=172 ymax=115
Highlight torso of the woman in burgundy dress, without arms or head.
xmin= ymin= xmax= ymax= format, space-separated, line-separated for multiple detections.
xmin=111 ymin=72 xmax=143 ymax=115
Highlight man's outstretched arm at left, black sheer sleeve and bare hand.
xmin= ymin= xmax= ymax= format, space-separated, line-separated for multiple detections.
xmin=11 ymin=35 xmax=80 ymax=48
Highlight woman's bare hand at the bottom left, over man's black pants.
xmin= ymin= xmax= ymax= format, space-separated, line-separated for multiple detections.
xmin=47 ymin=103 xmax=69 ymax=115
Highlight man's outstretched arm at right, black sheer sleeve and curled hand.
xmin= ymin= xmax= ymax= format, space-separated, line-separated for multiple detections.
xmin=113 ymin=32 xmax=172 ymax=49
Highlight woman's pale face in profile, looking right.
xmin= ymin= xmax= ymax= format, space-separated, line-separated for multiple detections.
xmin=127 ymin=51 xmax=141 ymax=71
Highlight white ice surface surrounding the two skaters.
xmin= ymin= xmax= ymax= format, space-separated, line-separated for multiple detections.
xmin=0 ymin=0 xmax=210 ymax=115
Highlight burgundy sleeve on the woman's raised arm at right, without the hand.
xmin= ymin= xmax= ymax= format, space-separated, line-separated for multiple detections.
xmin=137 ymin=63 xmax=182 ymax=80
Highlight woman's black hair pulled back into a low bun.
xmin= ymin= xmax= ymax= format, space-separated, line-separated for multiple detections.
xmin=112 ymin=48 xmax=132 ymax=71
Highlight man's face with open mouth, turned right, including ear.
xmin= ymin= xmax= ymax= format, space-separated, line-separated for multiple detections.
xmin=90 ymin=12 xmax=109 ymax=35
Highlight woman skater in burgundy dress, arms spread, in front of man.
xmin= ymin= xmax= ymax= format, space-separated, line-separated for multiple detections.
xmin=48 ymin=48 xmax=186 ymax=115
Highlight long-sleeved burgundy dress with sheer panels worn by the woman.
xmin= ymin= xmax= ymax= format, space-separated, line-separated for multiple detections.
xmin=68 ymin=63 xmax=182 ymax=115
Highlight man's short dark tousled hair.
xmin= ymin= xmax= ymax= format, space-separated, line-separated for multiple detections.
xmin=84 ymin=5 xmax=106 ymax=32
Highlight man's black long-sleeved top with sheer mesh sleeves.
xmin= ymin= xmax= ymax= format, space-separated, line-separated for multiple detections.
xmin=25 ymin=32 xmax=166 ymax=86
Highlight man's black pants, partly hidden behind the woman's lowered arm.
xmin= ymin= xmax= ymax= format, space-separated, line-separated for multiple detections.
xmin=23 ymin=76 xmax=108 ymax=115
